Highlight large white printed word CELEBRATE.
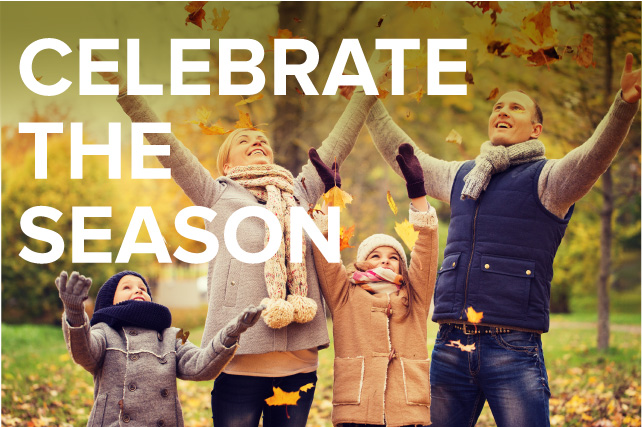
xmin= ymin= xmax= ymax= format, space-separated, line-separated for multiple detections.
xmin=20 ymin=38 xmax=467 ymax=96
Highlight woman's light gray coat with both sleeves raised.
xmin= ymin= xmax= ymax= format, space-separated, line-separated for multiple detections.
xmin=118 ymin=95 xmax=376 ymax=355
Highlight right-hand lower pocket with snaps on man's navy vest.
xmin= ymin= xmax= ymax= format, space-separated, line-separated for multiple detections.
xmin=474 ymin=255 xmax=535 ymax=319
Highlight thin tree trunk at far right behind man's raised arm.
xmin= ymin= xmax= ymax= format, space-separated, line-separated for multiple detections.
xmin=597 ymin=12 xmax=614 ymax=351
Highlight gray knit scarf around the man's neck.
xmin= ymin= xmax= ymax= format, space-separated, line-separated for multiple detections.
xmin=461 ymin=139 xmax=546 ymax=200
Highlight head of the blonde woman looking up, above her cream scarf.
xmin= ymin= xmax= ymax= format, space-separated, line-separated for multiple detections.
xmin=224 ymin=130 xmax=274 ymax=175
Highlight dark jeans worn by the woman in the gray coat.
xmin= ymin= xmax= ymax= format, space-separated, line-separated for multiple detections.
xmin=212 ymin=371 xmax=317 ymax=427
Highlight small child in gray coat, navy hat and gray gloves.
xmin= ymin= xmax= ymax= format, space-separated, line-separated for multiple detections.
xmin=56 ymin=271 xmax=264 ymax=427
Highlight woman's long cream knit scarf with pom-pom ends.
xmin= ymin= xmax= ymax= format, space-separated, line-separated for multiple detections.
xmin=227 ymin=164 xmax=317 ymax=328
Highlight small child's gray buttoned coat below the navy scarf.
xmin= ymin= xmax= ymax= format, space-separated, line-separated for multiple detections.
xmin=62 ymin=314 xmax=238 ymax=427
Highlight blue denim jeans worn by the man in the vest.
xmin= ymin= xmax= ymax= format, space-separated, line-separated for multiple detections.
xmin=430 ymin=325 xmax=551 ymax=427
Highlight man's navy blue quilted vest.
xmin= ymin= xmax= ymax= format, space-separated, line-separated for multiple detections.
xmin=432 ymin=160 xmax=574 ymax=332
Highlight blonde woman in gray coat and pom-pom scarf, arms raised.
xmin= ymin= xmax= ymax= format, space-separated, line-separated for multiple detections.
xmin=101 ymin=59 xmax=385 ymax=427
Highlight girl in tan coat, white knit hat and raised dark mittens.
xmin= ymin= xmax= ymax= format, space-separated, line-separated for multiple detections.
xmin=310 ymin=144 xmax=438 ymax=427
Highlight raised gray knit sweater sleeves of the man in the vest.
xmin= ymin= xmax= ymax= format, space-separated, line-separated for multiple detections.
xmin=362 ymin=92 xmax=640 ymax=218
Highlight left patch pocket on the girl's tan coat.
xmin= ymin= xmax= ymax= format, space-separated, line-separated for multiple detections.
xmin=332 ymin=356 xmax=365 ymax=405
